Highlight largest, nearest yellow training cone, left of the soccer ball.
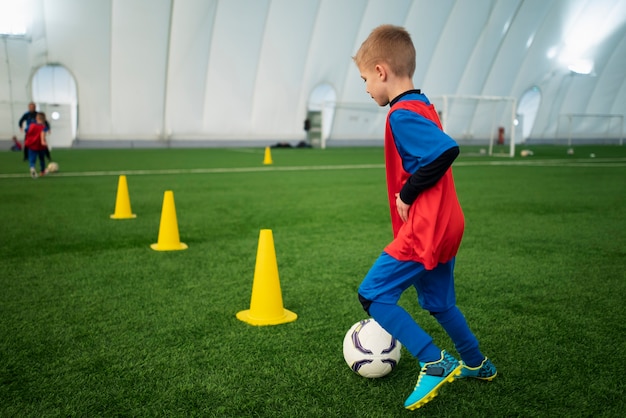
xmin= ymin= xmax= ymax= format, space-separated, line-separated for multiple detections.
xmin=237 ymin=229 xmax=298 ymax=325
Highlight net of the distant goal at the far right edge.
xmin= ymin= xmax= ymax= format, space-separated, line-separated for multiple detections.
xmin=555 ymin=113 xmax=624 ymax=146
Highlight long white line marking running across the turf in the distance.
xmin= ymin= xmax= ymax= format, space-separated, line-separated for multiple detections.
xmin=0 ymin=158 xmax=626 ymax=179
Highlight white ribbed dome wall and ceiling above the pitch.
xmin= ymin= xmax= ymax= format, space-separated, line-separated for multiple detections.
xmin=0 ymin=0 xmax=626 ymax=145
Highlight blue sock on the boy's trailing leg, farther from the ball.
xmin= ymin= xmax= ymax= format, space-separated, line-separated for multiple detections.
xmin=431 ymin=306 xmax=485 ymax=367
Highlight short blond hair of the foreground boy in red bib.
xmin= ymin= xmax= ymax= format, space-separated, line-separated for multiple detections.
xmin=352 ymin=25 xmax=415 ymax=78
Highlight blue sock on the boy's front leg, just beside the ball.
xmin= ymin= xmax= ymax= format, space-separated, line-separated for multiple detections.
xmin=369 ymin=302 xmax=441 ymax=363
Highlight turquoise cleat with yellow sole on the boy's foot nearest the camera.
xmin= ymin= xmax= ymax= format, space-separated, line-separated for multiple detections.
xmin=404 ymin=350 xmax=462 ymax=410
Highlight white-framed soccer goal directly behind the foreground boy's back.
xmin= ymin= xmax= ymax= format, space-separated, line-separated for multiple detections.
xmin=431 ymin=95 xmax=517 ymax=157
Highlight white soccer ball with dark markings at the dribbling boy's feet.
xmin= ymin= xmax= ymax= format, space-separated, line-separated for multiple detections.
xmin=343 ymin=318 xmax=402 ymax=378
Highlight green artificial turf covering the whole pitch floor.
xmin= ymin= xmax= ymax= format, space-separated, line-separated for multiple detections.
xmin=0 ymin=146 xmax=626 ymax=417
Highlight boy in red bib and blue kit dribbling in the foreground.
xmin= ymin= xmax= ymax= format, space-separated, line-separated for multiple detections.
xmin=353 ymin=25 xmax=496 ymax=410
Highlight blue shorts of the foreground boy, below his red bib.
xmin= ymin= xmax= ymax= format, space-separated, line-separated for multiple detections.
xmin=359 ymin=252 xmax=456 ymax=312
